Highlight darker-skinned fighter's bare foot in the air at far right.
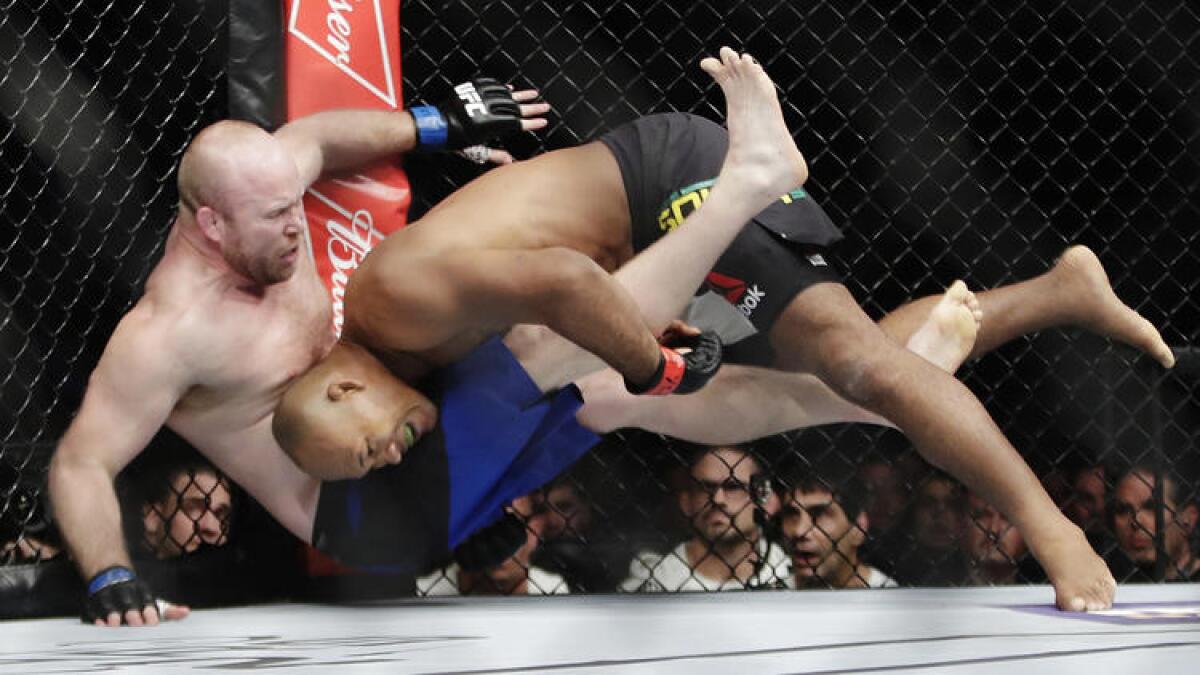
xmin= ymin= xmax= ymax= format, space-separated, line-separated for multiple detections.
xmin=1050 ymin=246 xmax=1175 ymax=368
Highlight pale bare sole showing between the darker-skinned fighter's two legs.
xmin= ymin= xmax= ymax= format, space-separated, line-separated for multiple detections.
xmin=906 ymin=280 xmax=983 ymax=372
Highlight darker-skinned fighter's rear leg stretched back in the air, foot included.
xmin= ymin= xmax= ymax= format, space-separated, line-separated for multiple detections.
xmin=880 ymin=246 xmax=1175 ymax=368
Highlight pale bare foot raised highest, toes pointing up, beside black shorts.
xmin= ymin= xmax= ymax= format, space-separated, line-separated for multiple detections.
xmin=700 ymin=47 xmax=809 ymax=208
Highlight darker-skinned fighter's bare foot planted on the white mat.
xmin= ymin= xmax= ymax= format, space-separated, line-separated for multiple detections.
xmin=1030 ymin=522 xmax=1117 ymax=611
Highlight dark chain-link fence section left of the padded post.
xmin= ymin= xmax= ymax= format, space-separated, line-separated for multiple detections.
xmin=0 ymin=0 xmax=228 ymax=562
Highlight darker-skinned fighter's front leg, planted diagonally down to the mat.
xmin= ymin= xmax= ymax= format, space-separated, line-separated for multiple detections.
xmin=769 ymin=278 xmax=1116 ymax=610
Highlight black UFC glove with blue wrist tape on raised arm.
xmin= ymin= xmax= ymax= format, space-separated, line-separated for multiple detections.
xmin=408 ymin=77 xmax=521 ymax=150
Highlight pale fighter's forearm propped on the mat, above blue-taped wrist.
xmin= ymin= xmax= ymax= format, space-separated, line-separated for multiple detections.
xmin=49 ymin=454 xmax=130 ymax=579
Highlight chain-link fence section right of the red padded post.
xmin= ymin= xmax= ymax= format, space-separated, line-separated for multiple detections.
xmin=402 ymin=0 xmax=1200 ymax=592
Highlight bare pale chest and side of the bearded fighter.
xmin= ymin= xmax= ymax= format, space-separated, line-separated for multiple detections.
xmin=152 ymin=225 xmax=334 ymax=538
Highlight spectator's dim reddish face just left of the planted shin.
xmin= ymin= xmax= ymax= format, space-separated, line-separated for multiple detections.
xmin=962 ymin=492 xmax=1036 ymax=586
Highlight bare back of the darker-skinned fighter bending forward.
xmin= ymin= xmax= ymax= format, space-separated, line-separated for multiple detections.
xmin=343 ymin=143 xmax=648 ymax=382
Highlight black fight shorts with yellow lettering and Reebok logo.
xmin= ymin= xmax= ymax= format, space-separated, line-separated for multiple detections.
xmin=600 ymin=113 xmax=841 ymax=365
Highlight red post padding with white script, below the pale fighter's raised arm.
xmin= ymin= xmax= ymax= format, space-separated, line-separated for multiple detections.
xmin=308 ymin=189 xmax=384 ymax=335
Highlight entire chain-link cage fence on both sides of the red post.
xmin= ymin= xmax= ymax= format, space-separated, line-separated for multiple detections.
xmin=0 ymin=0 xmax=1200 ymax=593
